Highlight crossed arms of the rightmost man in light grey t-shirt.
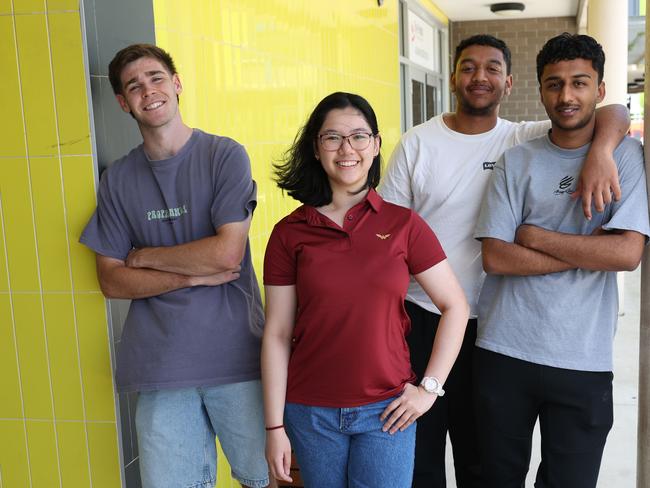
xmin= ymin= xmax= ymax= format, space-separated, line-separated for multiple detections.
xmin=481 ymin=224 xmax=645 ymax=276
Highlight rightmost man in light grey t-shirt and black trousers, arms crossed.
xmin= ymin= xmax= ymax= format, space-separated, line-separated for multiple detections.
xmin=475 ymin=33 xmax=650 ymax=488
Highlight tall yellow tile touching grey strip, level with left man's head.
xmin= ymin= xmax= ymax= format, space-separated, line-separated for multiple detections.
xmin=49 ymin=12 xmax=90 ymax=154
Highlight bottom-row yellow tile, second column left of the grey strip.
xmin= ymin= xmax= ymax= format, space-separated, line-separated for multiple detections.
xmin=56 ymin=422 xmax=91 ymax=488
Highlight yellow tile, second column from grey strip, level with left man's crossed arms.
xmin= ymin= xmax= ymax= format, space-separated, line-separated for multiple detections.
xmin=29 ymin=158 xmax=72 ymax=291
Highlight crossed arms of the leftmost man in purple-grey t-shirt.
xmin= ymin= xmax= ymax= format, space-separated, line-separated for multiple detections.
xmin=97 ymin=217 xmax=251 ymax=299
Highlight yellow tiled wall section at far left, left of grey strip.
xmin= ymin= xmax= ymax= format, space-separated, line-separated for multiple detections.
xmin=0 ymin=0 xmax=120 ymax=488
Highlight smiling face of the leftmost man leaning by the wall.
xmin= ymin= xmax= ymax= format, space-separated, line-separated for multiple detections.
xmin=116 ymin=57 xmax=183 ymax=128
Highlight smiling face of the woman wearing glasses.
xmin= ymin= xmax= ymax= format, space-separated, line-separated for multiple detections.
xmin=314 ymin=107 xmax=380 ymax=193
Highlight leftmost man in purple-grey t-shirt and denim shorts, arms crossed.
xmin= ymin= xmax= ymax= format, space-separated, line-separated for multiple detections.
xmin=80 ymin=44 xmax=269 ymax=488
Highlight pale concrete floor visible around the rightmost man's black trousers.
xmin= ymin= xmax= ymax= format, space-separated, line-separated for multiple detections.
xmin=447 ymin=268 xmax=641 ymax=488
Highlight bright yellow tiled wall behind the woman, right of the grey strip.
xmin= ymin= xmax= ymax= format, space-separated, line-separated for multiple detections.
xmin=154 ymin=0 xmax=400 ymax=286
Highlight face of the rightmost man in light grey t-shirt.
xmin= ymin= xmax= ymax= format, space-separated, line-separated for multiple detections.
xmin=540 ymin=58 xmax=605 ymax=138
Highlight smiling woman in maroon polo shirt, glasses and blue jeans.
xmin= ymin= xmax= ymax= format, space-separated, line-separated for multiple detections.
xmin=262 ymin=92 xmax=468 ymax=488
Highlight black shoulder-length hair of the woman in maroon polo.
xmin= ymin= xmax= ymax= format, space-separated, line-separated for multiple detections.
xmin=273 ymin=92 xmax=381 ymax=207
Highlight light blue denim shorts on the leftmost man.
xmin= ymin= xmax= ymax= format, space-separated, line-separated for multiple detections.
xmin=135 ymin=380 xmax=269 ymax=488
